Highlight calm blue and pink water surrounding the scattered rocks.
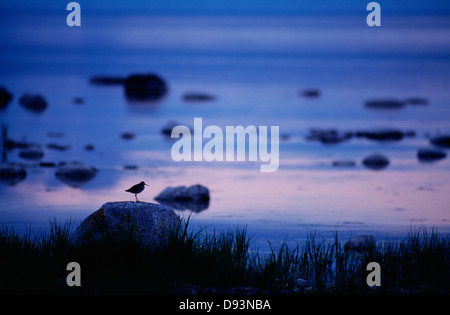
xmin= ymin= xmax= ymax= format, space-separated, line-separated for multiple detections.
xmin=0 ymin=11 xmax=450 ymax=251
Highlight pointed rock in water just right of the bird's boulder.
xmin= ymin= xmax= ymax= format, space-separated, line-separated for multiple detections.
xmin=155 ymin=185 xmax=210 ymax=212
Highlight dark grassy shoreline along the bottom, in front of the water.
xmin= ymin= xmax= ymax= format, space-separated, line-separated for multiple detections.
xmin=0 ymin=221 xmax=450 ymax=297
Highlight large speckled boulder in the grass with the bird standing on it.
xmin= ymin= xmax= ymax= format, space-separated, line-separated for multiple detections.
xmin=72 ymin=201 xmax=180 ymax=248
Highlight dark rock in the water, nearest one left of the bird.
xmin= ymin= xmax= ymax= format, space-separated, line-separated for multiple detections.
xmin=55 ymin=162 xmax=97 ymax=187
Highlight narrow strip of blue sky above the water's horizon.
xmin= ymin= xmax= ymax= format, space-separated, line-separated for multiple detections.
xmin=0 ymin=0 xmax=450 ymax=15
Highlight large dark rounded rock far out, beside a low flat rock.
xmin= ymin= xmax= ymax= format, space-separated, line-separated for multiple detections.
xmin=124 ymin=74 xmax=167 ymax=101
